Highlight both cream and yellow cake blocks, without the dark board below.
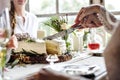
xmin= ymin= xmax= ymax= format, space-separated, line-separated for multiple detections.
xmin=15 ymin=40 xmax=66 ymax=55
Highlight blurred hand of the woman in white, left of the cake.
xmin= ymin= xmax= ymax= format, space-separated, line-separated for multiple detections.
xmin=6 ymin=35 xmax=18 ymax=49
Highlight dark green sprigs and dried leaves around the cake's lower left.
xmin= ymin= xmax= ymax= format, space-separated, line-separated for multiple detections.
xmin=6 ymin=49 xmax=46 ymax=68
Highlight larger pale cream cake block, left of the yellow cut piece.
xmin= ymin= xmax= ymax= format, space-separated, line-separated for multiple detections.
xmin=15 ymin=40 xmax=47 ymax=54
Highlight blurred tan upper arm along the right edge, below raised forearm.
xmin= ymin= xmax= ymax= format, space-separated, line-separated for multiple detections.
xmin=103 ymin=24 xmax=120 ymax=80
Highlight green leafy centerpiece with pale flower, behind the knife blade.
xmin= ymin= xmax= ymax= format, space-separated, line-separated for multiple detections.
xmin=44 ymin=16 xmax=71 ymax=52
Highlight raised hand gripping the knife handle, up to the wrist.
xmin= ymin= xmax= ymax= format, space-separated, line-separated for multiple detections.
xmin=75 ymin=5 xmax=102 ymax=28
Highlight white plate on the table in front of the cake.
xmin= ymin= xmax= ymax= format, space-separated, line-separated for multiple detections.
xmin=46 ymin=64 xmax=100 ymax=75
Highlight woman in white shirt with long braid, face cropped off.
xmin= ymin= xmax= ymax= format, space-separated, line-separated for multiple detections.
xmin=10 ymin=0 xmax=38 ymax=38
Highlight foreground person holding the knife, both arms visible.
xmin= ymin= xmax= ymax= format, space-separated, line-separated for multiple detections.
xmin=25 ymin=5 xmax=120 ymax=80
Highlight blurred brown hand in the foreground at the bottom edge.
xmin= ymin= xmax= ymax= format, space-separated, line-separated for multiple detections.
xmin=27 ymin=69 xmax=80 ymax=80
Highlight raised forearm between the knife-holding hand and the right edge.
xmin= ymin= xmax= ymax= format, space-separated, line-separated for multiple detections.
xmin=98 ymin=6 xmax=119 ymax=32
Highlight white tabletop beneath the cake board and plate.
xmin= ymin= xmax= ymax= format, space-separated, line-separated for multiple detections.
xmin=5 ymin=55 xmax=107 ymax=80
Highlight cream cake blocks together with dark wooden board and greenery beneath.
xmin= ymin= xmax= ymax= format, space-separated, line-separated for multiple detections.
xmin=9 ymin=40 xmax=72 ymax=64
